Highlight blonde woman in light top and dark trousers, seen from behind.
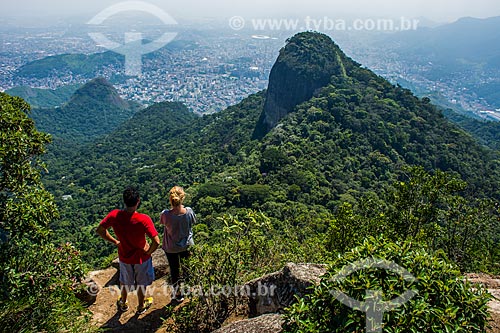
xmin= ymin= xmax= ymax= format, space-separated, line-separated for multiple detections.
xmin=160 ymin=186 xmax=196 ymax=302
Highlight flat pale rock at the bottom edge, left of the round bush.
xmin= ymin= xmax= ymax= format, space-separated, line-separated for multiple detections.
xmin=213 ymin=314 xmax=283 ymax=333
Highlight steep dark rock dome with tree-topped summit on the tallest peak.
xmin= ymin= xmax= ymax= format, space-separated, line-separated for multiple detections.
xmin=254 ymin=32 xmax=356 ymax=138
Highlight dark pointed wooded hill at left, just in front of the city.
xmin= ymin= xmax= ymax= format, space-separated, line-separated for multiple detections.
xmin=31 ymin=78 xmax=139 ymax=142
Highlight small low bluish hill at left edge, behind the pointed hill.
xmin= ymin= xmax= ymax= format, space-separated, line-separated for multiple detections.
xmin=5 ymin=85 xmax=80 ymax=108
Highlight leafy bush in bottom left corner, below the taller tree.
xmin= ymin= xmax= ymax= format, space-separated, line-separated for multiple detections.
xmin=0 ymin=240 xmax=92 ymax=332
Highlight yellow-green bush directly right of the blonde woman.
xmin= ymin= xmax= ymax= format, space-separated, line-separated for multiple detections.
xmin=167 ymin=211 xmax=290 ymax=332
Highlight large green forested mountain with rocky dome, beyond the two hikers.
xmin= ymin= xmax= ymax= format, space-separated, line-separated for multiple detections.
xmin=44 ymin=33 xmax=500 ymax=270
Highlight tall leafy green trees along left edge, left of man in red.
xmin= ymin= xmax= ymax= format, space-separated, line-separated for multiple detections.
xmin=0 ymin=93 xmax=94 ymax=332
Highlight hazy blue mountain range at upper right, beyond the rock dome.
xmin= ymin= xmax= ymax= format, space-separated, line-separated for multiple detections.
xmin=384 ymin=17 xmax=500 ymax=108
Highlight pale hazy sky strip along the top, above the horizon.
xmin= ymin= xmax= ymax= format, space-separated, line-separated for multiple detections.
xmin=0 ymin=0 xmax=500 ymax=22
